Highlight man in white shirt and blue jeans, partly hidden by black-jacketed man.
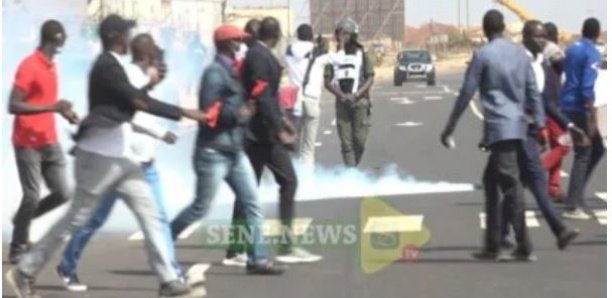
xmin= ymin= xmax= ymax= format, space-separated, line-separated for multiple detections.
xmin=57 ymin=34 xmax=182 ymax=292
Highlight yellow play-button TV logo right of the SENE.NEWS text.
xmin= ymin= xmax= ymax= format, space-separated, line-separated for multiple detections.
xmin=360 ymin=198 xmax=431 ymax=274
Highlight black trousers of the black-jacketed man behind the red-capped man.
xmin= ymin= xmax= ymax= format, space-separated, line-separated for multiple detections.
xmin=227 ymin=142 xmax=297 ymax=257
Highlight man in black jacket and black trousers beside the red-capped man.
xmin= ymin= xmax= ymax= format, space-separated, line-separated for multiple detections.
xmin=242 ymin=17 xmax=321 ymax=263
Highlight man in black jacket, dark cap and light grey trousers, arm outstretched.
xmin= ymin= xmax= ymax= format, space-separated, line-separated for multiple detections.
xmin=7 ymin=15 xmax=206 ymax=298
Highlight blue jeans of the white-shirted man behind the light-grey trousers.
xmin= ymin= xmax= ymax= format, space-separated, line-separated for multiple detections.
xmin=59 ymin=163 xmax=182 ymax=276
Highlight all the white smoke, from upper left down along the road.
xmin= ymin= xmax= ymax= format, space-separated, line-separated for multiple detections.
xmin=0 ymin=4 xmax=473 ymax=240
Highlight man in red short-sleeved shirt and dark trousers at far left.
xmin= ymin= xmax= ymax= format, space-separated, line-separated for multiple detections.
xmin=8 ymin=20 xmax=78 ymax=264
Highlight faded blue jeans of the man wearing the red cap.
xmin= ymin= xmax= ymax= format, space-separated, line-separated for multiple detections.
xmin=171 ymin=148 xmax=268 ymax=264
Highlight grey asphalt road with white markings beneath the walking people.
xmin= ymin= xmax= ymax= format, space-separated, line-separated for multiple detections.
xmin=3 ymin=69 xmax=607 ymax=298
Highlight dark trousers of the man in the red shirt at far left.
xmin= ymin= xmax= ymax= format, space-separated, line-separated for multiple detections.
xmin=11 ymin=145 xmax=71 ymax=247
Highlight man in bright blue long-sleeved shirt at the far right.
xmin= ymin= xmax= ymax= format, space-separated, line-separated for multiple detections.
xmin=561 ymin=18 xmax=605 ymax=220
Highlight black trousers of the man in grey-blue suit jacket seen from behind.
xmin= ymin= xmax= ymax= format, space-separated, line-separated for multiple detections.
xmin=483 ymin=140 xmax=533 ymax=254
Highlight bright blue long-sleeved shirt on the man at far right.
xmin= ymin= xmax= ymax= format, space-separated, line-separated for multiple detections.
xmin=561 ymin=38 xmax=601 ymax=112
